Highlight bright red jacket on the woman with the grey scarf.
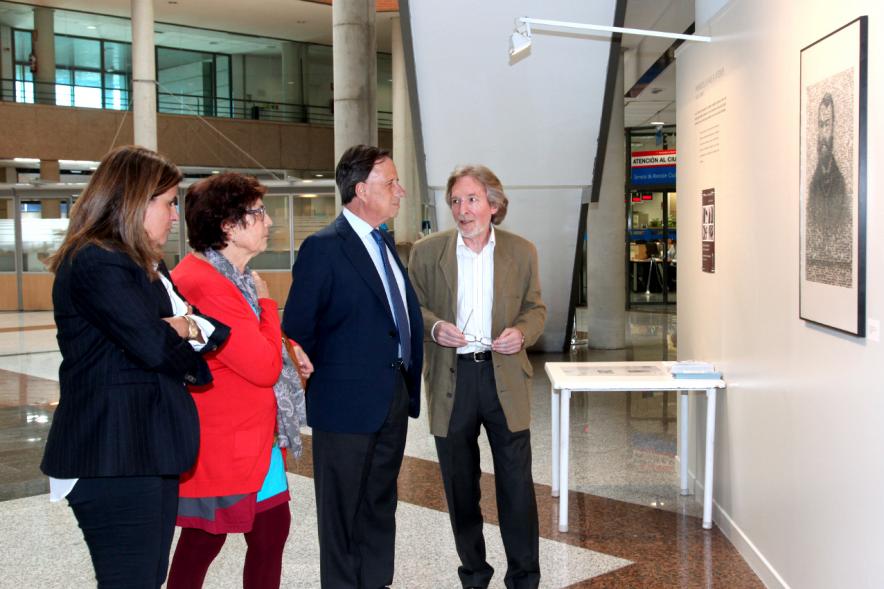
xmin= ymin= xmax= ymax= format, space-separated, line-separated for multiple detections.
xmin=172 ymin=254 xmax=282 ymax=497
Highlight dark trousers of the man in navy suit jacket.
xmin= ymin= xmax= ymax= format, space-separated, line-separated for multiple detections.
xmin=313 ymin=378 xmax=408 ymax=589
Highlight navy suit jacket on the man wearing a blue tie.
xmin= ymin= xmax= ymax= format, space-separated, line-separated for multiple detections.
xmin=282 ymin=214 xmax=423 ymax=433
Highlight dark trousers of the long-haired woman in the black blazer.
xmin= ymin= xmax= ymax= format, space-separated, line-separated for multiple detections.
xmin=68 ymin=476 xmax=178 ymax=589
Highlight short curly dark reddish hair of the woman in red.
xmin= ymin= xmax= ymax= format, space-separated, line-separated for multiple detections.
xmin=184 ymin=172 xmax=267 ymax=252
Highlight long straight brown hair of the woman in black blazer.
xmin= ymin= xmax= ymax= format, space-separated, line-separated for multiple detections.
xmin=47 ymin=145 xmax=183 ymax=278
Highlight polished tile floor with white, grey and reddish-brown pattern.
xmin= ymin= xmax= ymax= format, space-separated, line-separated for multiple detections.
xmin=0 ymin=311 xmax=762 ymax=589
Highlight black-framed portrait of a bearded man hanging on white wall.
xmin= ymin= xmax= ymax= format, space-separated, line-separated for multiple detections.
xmin=799 ymin=16 xmax=868 ymax=337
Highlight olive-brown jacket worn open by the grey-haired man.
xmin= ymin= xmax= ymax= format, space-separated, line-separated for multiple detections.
xmin=408 ymin=228 xmax=546 ymax=437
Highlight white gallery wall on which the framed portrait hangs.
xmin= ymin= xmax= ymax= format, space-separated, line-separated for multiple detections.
xmin=677 ymin=0 xmax=884 ymax=589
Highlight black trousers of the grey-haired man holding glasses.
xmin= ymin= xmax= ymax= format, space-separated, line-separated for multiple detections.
xmin=436 ymin=359 xmax=540 ymax=589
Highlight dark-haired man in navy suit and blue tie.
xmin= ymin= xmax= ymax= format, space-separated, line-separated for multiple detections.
xmin=282 ymin=145 xmax=423 ymax=589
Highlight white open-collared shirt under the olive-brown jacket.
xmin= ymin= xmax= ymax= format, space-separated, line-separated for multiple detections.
xmin=457 ymin=227 xmax=495 ymax=354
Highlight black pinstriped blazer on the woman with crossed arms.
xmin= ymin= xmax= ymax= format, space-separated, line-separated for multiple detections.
xmin=40 ymin=245 xmax=230 ymax=478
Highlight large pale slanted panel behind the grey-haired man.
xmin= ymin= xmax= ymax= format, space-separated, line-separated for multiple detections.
xmin=408 ymin=0 xmax=615 ymax=350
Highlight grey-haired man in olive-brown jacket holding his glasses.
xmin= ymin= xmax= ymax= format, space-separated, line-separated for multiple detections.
xmin=408 ymin=166 xmax=546 ymax=588
